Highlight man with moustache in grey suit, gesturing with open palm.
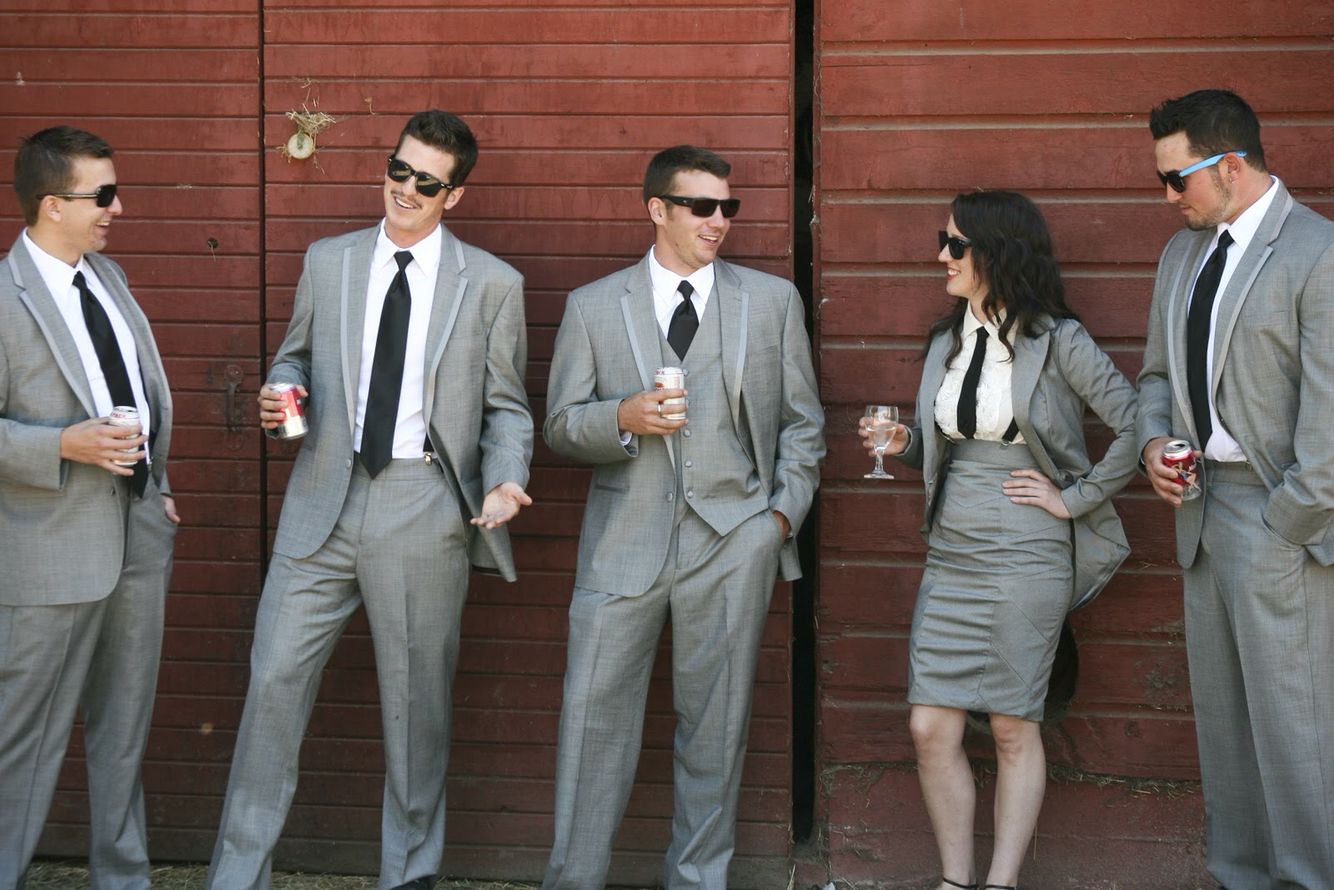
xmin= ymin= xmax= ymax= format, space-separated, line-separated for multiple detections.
xmin=208 ymin=111 xmax=532 ymax=890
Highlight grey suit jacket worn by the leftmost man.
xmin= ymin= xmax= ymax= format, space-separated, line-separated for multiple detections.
xmin=0 ymin=236 xmax=175 ymax=606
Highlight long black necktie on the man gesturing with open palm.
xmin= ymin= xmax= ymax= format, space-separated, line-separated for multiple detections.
xmin=362 ymin=251 xmax=412 ymax=476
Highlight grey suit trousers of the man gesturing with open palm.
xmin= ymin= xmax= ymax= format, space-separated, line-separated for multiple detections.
xmin=207 ymin=459 xmax=468 ymax=890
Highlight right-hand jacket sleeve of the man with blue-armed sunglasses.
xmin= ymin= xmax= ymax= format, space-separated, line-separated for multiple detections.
xmin=1265 ymin=238 xmax=1334 ymax=546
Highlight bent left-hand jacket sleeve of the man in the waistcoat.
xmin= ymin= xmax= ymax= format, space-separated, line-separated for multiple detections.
xmin=542 ymin=294 xmax=639 ymax=464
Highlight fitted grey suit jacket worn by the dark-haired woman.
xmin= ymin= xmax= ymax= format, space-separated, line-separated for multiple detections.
xmin=900 ymin=319 xmax=1135 ymax=608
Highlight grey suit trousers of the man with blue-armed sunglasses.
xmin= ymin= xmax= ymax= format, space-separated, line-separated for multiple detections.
xmin=1185 ymin=462 xmax=1334 ymax=890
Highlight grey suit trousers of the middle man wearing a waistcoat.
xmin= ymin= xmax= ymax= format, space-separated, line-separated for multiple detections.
xmin=542 ymin=510 xmax=782 ymax=890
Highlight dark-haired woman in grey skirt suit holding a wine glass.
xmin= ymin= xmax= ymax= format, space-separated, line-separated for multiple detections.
xmin=862 ymin=192 xmax=1135 ymax=890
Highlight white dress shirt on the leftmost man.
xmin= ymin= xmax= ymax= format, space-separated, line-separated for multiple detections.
xmin=23 ymin=230 xmax=152 ymax=454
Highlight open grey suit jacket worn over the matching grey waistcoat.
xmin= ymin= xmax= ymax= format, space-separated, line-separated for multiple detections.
xmin=543 ymin=256 xmax=824 ymax=595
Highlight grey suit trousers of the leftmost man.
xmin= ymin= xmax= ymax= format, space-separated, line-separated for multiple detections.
xmin=0 ymin=476 xmax=176 ymax=890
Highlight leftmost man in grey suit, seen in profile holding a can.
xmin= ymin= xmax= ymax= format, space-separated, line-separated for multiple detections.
xmin=0 ymin=127 xmax=180 ymax=890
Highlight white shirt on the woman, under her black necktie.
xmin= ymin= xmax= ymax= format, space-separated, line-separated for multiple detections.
xmin=935 ymin=308 xmax=1023 ymax=443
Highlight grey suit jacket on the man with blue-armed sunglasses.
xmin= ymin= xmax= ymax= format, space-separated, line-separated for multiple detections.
xmin=1138 ymin=183 xmax=1334 ymax=567
